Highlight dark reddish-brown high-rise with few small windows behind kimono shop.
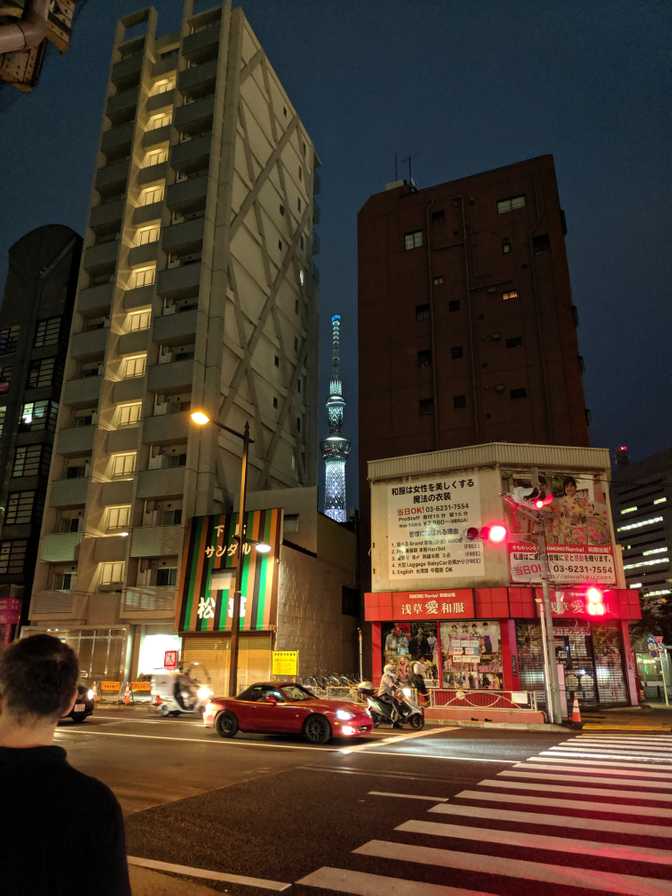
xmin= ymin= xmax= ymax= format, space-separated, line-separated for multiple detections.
xmin=358 ymin=155 xmax=589 ymax=584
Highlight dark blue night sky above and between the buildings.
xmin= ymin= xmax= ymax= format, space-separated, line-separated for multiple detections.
xmin=0 ymin=0 xmax=672 ymax=508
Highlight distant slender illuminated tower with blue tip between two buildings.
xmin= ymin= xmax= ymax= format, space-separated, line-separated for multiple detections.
xmin=321 ymin=314 xmax=350 ymax=523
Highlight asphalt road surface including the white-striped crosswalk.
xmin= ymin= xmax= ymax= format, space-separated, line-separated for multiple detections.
xmin=57 ymin=708 xmax=672 ymax=896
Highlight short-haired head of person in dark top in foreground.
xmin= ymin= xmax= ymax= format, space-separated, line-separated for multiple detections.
xmin=0 ymin=635 xmax=79 ymax=719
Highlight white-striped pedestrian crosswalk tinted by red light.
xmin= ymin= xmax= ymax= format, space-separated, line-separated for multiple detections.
xmin=295 ymin=733 xmax=672 ymax=896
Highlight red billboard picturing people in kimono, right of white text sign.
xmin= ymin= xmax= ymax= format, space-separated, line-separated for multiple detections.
xmin=502 ymin=471 xmax=616 ymax=585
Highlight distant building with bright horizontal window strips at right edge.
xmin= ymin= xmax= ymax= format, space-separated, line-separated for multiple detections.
xmin=611 ymin=446 xmax=672 ymax=624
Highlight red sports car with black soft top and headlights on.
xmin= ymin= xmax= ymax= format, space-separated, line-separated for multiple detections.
xmin=203 ymin=682 xmax=373 ymax=744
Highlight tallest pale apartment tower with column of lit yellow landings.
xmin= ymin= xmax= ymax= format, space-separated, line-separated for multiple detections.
xmin=30 ymin=0 xmax=319 ymax=677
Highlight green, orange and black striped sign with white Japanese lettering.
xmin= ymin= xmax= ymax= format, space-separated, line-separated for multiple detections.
xmin=178 ymin=508 xmax=282 ymax=632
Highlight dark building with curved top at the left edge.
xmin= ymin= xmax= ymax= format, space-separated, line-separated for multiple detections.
xmin=0 ymin=224 xmax=82 ymax=644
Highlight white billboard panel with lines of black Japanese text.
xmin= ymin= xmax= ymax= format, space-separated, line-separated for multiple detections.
xmin=388 ymin=471 xmax=484 ymax=580
